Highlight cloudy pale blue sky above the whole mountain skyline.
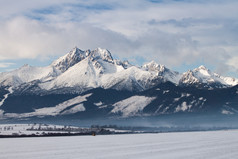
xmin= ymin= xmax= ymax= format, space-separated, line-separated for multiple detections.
xmin=0 ymin=0 xmax=238 ymax=78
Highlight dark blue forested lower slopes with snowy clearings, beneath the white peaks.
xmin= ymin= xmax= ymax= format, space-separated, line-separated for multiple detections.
xmin=0 ymin=82 xmax=238 ymax=119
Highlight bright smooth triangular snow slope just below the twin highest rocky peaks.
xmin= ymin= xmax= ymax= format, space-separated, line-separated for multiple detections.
xmin=40 ymin=57 xmax=124 ymax=90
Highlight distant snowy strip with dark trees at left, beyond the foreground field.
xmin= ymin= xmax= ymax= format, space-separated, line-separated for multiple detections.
xmin=0 ymin=124 xmax=114 ymax=138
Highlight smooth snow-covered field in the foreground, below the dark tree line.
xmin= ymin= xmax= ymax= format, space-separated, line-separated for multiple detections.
xmin=0 ymin=130 xmax=238 ymax=159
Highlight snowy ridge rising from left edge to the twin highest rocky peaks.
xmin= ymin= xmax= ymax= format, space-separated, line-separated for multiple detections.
xmin=0 ymin=48 xmax=113 ymax=87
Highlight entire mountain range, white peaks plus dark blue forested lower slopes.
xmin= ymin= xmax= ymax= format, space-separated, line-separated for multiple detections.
xmin=0 ymin=47 xmax=238 ymax=118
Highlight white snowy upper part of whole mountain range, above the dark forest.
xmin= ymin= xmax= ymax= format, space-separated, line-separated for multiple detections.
xmin=0 ymin=47 xmax=238 ymax=92
